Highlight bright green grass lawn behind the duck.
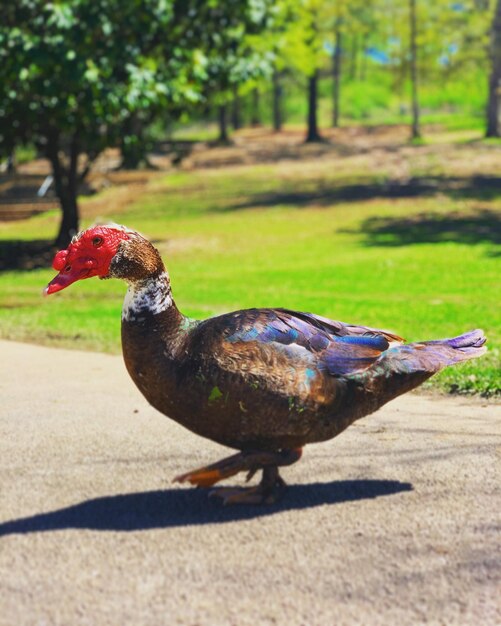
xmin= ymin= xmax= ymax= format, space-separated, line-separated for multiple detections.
xmin=0 ymin=144 xmax=501 ymax=395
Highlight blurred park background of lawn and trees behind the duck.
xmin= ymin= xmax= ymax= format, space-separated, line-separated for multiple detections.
xmin=0 ymin=0 xmax=501 ymax=397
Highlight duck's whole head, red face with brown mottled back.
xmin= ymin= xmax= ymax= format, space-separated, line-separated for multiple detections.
xmin=44 ymin=225 xmax=161 ymax=295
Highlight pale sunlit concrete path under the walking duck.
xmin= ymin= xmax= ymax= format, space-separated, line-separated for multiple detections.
xmin=0 ymin=342 xmax=501 ymax=626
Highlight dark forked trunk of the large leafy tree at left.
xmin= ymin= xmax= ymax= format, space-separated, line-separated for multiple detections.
xmin=47 ymin=133 xmax=80 ymax=248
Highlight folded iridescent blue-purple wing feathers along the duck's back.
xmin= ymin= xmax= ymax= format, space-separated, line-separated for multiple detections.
xmin=223 ymin=309 xmax=402 ymax=376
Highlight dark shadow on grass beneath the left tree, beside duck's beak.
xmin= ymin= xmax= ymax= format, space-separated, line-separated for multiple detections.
xmin=0 ymin=239 xmax=57 ymax=272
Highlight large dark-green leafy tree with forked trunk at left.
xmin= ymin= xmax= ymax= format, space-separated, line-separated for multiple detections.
xmin=0 ymin=0 xmax=267 ymax=246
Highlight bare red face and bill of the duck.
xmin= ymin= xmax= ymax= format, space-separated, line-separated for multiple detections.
xmin=44 ymin=226 xmax=129 ymax=295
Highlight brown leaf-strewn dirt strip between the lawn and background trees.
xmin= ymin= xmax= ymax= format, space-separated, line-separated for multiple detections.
xmin=0 ymin=124 xmax=499 ymax=221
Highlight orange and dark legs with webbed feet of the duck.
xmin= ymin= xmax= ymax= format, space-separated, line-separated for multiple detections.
xmin=174 ymin=448 xmax=302 ymax=504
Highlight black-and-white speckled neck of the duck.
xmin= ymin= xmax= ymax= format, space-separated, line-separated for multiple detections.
xmin=122 ymin=268 xmax=182 ymax=323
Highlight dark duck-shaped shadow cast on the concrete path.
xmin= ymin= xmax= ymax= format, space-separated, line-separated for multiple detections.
xmin=0 ymin=480 xmax=412 ymax=536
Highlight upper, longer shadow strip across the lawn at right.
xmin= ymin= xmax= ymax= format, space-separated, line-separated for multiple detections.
xmin=219 ymin=176 xmax=501 ymax=212
